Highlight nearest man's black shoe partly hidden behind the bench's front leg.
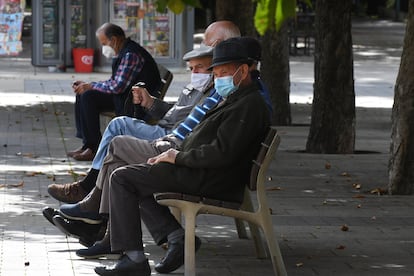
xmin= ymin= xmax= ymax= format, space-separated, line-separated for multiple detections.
xmin=154 ymin=236 xmax=201 ymax=273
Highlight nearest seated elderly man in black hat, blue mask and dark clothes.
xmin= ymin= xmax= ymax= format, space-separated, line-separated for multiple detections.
xmin=95 ymin=37 xmax=270 ymax=276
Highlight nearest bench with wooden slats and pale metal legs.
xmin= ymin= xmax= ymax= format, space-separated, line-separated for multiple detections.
xmin=154 ymin=128 xmax=287 ymax=276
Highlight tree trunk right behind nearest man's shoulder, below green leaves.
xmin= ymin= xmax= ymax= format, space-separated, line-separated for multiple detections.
xmin=260 ymin=24 xmax=292 ymax=126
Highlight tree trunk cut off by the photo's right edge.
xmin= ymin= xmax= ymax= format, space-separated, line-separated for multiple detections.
xmin=388 ymin=1 xmax=414 ymax=194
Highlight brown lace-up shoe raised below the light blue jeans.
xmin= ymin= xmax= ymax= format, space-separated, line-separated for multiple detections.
xmin=47 ymin=181 xmax=88 ymax=204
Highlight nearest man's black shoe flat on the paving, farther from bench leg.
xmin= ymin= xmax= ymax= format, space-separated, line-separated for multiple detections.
xmin=95 ymin=255 xmax=151 ymax=276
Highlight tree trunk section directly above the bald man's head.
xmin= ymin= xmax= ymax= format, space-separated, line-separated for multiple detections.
xmin=216 ymin=0 xmax=256 ymax=37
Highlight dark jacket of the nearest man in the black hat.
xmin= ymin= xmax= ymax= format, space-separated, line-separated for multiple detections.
xmin=150 ymin=84 xmax=270 ymax=202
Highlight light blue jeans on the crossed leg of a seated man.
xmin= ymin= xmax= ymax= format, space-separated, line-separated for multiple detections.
xmin=92 ymin=116 xmax=171 ymax=170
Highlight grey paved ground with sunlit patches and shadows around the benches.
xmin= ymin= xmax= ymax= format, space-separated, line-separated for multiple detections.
xmin=0 ymin=18 xmax=414 ymax=276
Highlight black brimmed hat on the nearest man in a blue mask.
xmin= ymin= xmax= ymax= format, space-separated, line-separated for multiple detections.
xmin=209 ymin=38 xmax=252 ymax=69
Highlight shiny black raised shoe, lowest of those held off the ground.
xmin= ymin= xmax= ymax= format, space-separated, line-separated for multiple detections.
xmin=53 ymin=215 xmax=106 ymax=247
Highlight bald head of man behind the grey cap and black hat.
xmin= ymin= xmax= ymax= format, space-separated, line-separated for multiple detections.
xmin=203 ymin=20 xmax=240 ymax=47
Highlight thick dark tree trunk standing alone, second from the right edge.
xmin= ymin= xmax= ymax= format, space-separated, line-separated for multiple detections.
xmin=306 ymin=0 xmax=355 ymax=153
